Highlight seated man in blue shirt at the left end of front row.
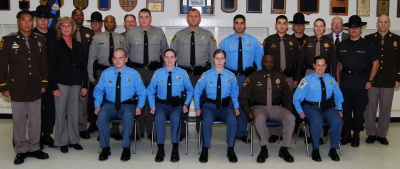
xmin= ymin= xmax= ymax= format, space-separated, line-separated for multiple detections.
xmin=93 ymin=48 xmax=146 ymax=161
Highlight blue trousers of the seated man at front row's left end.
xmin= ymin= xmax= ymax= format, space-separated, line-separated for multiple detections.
xmin=97 ymin=102 xmax=136 ymax=148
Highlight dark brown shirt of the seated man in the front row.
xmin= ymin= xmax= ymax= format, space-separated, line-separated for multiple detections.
xmin=239 ymin=70 xmax=293 ymax=113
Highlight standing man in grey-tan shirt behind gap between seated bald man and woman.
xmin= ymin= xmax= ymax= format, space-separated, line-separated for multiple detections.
xmin=123 ymin=8 xmax=168 ymax=139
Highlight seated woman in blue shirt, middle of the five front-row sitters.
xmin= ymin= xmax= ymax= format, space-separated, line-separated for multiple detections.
xmin=194 ymin=49 xmax=240 ymax=163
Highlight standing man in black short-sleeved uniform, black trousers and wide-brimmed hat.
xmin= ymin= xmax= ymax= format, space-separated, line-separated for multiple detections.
xmin=337 ymin=15 xmax=379 ymax=147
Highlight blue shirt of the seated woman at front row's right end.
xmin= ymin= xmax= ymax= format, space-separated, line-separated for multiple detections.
xmin=293 ymin=72 xmax=343 ymax=114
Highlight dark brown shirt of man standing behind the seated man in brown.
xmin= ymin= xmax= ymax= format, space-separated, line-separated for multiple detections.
xmin=263 ymin=34 xmax=301 ymax=81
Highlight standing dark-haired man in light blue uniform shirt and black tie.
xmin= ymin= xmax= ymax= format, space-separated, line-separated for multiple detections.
xmin=219 ymin=14 xmax=264 ymax=142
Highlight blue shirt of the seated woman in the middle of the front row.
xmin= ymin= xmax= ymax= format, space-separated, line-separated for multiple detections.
xmin=194 ymin=68 xmax=239 ymax=109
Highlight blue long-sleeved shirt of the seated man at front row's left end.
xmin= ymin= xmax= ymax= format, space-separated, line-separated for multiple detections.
xmin=93 ymin=66 xmax=146 ymax=108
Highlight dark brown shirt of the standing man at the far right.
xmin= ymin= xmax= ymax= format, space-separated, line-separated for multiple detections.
xmin=365 ymin=32 xmax=400 ymax=88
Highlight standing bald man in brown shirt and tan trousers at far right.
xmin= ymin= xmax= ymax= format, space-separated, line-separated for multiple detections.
xmin=364 ymin=15 xmax=400 ymax=145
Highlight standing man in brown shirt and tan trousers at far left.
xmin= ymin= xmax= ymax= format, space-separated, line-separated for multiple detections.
xmin=0 ymin=10 xmax=49 ymax=164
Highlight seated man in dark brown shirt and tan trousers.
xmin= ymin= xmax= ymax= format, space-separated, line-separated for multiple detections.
xmin=239 ymin=55 xmax=295 ymax=163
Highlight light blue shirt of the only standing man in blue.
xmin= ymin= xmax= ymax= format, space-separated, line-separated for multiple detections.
xmin=219 ymin=33 xmax=264 ymax=70
